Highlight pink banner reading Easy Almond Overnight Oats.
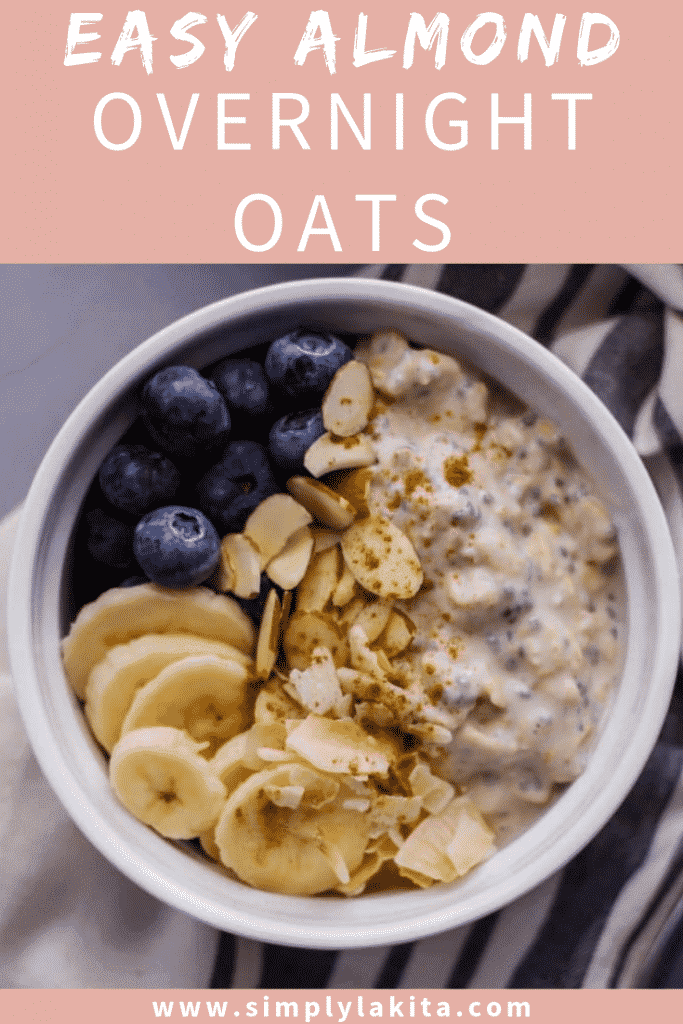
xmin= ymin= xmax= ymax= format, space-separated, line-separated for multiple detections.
xmin=2 ymin=0 xmax=683 ymax=262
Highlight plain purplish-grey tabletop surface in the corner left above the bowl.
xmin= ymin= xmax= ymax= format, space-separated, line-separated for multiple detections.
xmin=0 ymin=263 xmax=358 ymax=516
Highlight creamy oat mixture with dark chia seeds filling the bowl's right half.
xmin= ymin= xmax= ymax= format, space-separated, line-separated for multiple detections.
xmin=355 ymin=335 xmax=624 ymax=844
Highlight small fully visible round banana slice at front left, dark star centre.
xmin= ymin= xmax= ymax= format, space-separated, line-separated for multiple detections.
xmin=110 ymin=726 xmax=225 ymax=839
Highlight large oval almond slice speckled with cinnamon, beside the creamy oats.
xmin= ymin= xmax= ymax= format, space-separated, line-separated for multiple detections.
xmin=341 ymin=515 xmax=424 ymax=600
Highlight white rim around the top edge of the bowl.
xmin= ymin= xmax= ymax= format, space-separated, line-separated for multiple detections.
xmin=8 ymin=278 xmax=681 ymax=948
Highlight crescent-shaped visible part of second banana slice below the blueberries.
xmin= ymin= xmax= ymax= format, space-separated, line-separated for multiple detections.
xmin=85 ymin=633 xmax=253 ymax=754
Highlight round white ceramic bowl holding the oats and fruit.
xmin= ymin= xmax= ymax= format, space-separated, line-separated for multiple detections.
xmin=9 ymin=279 xmax=681 ymax=948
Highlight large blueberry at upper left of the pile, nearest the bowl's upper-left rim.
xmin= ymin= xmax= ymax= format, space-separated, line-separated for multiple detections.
xmin=142 ymin=367 xmax=230 ymax=459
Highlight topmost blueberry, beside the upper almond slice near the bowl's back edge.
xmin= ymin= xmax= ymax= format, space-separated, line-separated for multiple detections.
xmin=265 ymin=331 xmax=352 ymax=406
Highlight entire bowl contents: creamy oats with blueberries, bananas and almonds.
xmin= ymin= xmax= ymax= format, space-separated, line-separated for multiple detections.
xmin=63 ymin=331 xmax=624 ymax=896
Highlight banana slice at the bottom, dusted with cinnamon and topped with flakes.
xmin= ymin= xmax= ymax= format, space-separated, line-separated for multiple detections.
xmin=215 ymin=764 xmax=369 ymax=896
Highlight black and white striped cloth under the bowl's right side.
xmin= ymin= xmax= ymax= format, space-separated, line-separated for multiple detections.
xmin=212 ymin=264 xmax=683 ymax=988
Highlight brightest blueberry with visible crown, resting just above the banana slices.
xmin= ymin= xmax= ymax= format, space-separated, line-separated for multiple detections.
xmin=133 ymin=505 xmax=220 ymax=588
